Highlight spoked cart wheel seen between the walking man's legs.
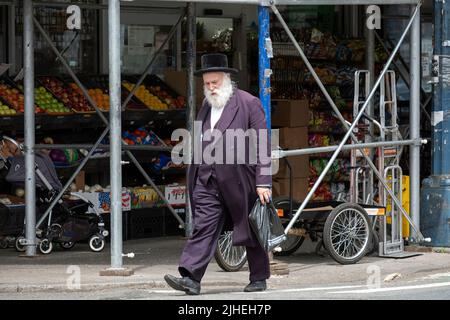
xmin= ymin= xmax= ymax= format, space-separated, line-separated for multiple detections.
xmin=214 ymin=231 xmax=247 ymax=272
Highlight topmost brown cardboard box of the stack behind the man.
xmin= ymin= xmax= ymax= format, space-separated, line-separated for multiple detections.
xmin=271 ymin=100 xmax=309 ymax=127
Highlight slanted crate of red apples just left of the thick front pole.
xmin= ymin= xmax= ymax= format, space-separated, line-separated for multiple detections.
xmin=38 ymin=76 xmax=95 ymax=114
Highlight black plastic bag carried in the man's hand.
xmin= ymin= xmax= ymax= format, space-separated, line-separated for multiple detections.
xmin=248 ymin=198 xmax=286 ymax=251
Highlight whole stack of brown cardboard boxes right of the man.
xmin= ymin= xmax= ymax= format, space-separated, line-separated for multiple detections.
xmin=271 ymin=100 xmax=309 ymax=201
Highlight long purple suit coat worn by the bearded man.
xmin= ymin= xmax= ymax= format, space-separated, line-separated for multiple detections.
xmin=188 ymin=89 xmax=272 ymax=246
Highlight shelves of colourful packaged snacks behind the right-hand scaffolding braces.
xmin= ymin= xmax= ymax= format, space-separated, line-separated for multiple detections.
xmin=271 ymin=24 xmax=362 ymax=201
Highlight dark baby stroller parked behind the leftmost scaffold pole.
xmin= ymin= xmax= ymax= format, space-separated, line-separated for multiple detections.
xmin=0 ymin=136 xmax=109 ymax=254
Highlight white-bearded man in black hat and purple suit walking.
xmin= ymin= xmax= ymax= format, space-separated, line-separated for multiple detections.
xmin=164 ymin=54 xmax=272 ymax=295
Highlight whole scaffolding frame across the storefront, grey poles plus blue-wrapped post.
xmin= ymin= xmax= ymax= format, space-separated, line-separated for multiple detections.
xmin=2 ymin=0 xmax=424 ymax=268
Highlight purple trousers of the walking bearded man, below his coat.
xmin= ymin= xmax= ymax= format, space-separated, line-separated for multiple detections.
xmin=178 ymin=176 xmax=270 ymax=282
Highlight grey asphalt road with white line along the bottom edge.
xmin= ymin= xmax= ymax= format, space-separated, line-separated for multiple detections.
xmin=0 ymin=273 xmax=450 ymax=302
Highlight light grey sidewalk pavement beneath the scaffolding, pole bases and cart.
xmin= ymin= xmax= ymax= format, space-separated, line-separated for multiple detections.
xmin=0 ymin=236 xmax=450 ymax=292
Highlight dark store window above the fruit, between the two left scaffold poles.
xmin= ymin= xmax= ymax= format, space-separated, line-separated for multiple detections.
xmin=16 ymin=0 xmax=98 ymax=74
